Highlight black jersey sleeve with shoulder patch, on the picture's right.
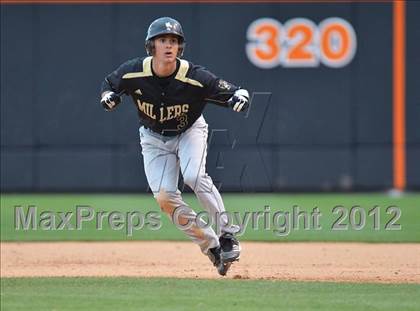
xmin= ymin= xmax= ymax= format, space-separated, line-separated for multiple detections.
xmin=199 ymin=68 xmax=239 ymax=107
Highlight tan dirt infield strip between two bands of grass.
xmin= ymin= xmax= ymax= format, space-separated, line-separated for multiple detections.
xmin=1 ymin=242 xmax=420 ymax=283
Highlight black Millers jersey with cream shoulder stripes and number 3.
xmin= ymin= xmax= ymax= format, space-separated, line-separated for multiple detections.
xmin=101 ymin=56 xmax=239 ymax=136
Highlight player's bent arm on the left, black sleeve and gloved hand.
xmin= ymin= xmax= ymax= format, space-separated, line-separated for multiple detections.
xmin=101 ymin=62 xmax=132 ymax=111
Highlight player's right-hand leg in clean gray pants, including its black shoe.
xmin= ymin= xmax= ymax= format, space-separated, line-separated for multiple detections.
xmin=178 ymin=117 xmax=240 ymax=261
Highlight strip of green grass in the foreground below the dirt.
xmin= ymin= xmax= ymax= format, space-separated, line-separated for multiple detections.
xmin=1 ymin=278 xmax=420 ymax=311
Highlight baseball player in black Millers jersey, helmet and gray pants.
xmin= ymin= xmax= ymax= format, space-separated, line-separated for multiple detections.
xmin=101 ymin=17 xmax=249 ymax=275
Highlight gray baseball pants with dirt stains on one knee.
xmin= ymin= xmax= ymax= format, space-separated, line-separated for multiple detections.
xmin=139 ymin=116 xmax=239 ymax=254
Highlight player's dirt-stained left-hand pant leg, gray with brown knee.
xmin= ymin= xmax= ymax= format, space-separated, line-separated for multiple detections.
xmin=140 ymin=128 xmax=219 ymax=254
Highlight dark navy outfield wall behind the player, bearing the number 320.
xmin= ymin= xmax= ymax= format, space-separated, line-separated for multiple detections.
xmin=0 ymin=1 xmax=420 ymax=192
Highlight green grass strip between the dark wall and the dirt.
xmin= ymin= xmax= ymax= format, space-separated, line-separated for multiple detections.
xmin=1 ymin=193 xmax=420 ymax=242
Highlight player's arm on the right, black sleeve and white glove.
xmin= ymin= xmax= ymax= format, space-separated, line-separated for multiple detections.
xmin=202 ymin=70 xmax=249 ymax=112
